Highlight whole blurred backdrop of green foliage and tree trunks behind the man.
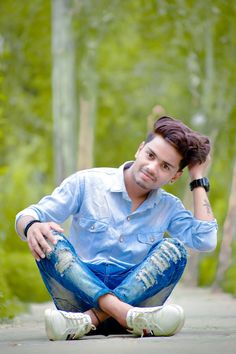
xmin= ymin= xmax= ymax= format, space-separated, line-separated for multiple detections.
xmin=0 ymin=0 xmax=236 ymax=319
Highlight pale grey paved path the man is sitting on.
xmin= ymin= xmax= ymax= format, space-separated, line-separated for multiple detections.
xmin=0 ymin=286 xmax=236 ymax=354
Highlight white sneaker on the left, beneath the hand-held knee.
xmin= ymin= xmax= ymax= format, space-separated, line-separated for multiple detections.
xmin=44 ymin=309 xmax=96 ymax=340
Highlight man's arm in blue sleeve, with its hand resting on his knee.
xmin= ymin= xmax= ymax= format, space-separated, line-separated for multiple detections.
xmin=16 ymin=174 xmax=80 ymax=260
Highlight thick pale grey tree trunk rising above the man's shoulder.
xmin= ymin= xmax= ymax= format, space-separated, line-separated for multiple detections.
xmin=52 ymin=0 xmax=77 ymax=184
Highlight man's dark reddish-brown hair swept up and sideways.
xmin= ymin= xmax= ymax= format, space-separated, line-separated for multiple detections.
xmin=145 ymin=116 xmax=211 ymax=170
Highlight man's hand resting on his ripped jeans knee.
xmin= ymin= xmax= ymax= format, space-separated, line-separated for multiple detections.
xmin=27 ymin=222 xmax=64 ymax=261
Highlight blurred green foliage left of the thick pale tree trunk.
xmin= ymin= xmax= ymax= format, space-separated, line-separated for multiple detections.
xmin=0 ymin=0 xmax=53 ymax=318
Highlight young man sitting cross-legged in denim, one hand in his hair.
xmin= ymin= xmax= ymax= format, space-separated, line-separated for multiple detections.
xmin=16 ymin=117 xmax=217 ymax=340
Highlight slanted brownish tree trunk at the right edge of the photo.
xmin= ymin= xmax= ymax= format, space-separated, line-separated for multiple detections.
xmin=213 ymin=159 xmax=236 ymax=289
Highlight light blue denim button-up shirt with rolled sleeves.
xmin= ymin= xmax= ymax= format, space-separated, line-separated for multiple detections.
xmin=16 ymin=163 xmax=217 ymax=270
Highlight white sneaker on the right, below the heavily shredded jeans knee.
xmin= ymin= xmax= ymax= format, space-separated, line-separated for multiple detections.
xmin=126 ymin=304 xmax=185 ymax=336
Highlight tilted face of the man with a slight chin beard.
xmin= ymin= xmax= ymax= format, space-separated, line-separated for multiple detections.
xmin=130 ymin=135 xmax=182 ymax=192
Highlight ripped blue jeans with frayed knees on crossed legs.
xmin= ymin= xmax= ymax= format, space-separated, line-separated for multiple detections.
xmin=37 ymin=233 xmax=187 ymax=312
